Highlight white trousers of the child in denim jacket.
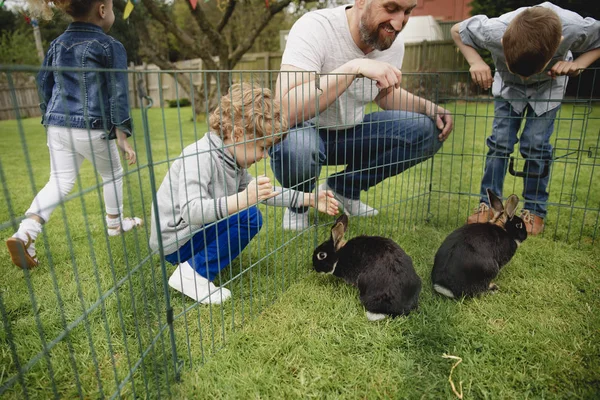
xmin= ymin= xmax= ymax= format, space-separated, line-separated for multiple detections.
xmin=25 ymin=126 xmax=123 ymax=221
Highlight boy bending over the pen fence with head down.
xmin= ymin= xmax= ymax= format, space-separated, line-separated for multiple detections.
xmin=452 ymin=2 xmax=600 ymax=235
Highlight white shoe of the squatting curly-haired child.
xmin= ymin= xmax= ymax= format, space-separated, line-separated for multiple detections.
xmin=169 ymin=262 xmax=231 ymax=304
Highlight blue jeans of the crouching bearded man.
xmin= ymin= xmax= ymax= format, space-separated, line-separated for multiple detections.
xmin=270 ymin=111 xmax=442 ymax=212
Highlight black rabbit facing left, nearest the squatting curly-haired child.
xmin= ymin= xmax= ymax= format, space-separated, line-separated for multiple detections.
xmin=313 ymin=214 xmax=421 ymax=321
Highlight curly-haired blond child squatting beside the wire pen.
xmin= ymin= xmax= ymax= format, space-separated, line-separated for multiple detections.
xmin=150 ymin=84 xmax=338 ymax=304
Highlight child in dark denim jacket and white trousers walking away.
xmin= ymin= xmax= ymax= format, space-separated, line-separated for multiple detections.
xmin=6 ymin=0 xmax=142 ymax=268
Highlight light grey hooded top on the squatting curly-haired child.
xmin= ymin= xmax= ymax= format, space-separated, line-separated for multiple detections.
xmin=150 ymin=132 xmax=304 ymax=255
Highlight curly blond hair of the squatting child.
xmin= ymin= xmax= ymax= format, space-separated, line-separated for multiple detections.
xmin=209 ymin=83 xmax=288 ymax=145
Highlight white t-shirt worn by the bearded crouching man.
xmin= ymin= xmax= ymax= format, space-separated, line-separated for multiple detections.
xmin=281 ymin=5 xmax=404 ymax=129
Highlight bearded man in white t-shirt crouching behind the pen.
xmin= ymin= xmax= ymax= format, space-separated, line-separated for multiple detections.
xmin=270 ymin=0 xmax=453 ymax=230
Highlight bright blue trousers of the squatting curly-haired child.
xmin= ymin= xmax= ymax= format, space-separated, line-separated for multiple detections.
xmin=165 ymin=206 xmax=263 ymax=281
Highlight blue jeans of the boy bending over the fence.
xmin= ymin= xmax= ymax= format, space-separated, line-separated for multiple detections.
xmin=480 ymin=100 xmax=560 ymax=218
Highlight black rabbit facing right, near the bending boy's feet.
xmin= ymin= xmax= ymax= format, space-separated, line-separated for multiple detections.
xmin=431 ymin=189 xmax=527 ymax=298
